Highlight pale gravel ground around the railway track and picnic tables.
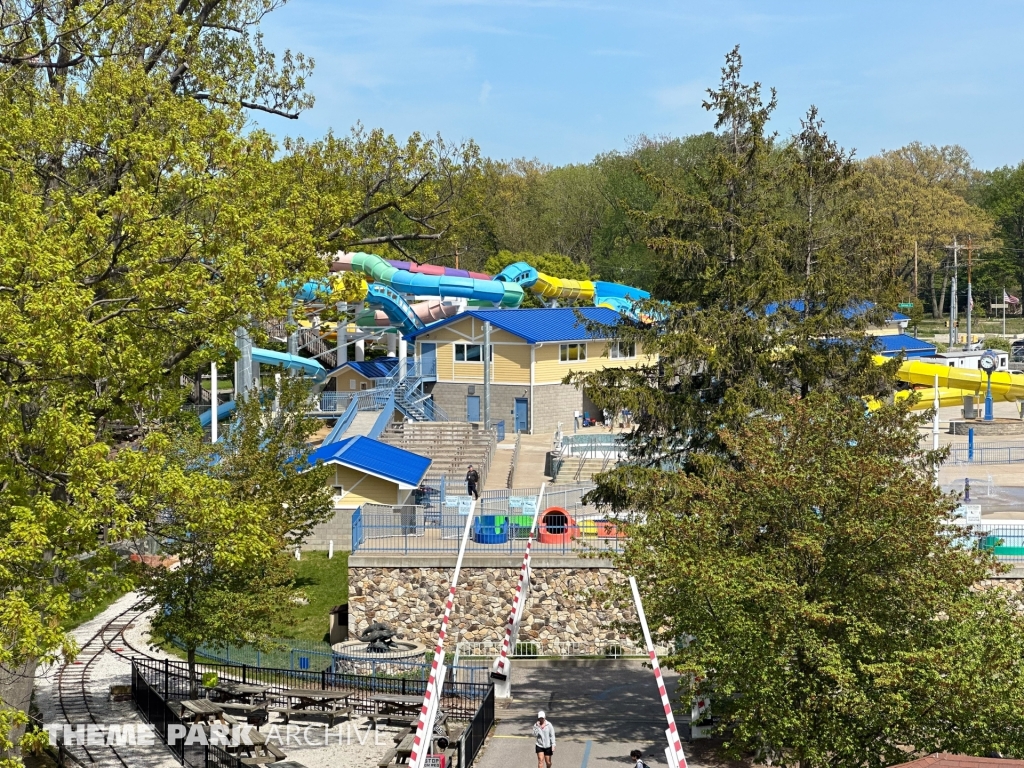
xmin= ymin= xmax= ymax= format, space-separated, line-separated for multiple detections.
xmin=36 ymin=593 xmax=397 ymax=768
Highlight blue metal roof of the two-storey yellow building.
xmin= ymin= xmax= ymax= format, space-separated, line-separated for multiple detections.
xmin=406 ymin=306 xmax=622 ymax=344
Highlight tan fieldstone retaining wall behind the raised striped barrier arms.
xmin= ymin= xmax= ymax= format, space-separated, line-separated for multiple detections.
xmin=348 ymin=566 xmax=635 ymax=647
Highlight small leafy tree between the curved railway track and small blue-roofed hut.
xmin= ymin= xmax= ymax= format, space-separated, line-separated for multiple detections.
xmin=142 ymin=375 xmax=332 ymax=693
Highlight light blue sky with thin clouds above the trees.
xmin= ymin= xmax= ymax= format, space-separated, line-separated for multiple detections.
xmin=260 ymin=0 xmax=1024 ymax=168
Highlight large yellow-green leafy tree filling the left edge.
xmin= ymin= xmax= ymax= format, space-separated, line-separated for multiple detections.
xmin=0 ymin=0 xmax=325 ymax=753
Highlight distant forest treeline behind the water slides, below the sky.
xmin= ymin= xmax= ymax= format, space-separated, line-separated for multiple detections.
xmin=329 ymin=128 xmax=1024 ymax=317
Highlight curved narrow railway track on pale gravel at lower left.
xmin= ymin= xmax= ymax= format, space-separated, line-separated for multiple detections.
xmin=56 ymin=601 xmax=164 ymax=768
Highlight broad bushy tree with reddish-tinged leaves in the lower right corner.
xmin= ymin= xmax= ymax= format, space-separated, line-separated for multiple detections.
xmin=618 ymin=393 xmax=1024 ymax=768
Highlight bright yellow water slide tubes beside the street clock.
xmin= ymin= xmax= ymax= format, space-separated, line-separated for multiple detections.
xmin=868 ymin=355 xmax=1024 ymax=410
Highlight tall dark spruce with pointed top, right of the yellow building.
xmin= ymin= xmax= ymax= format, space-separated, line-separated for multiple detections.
xmin=572 ymin=50 xmax=890 ymax=468
